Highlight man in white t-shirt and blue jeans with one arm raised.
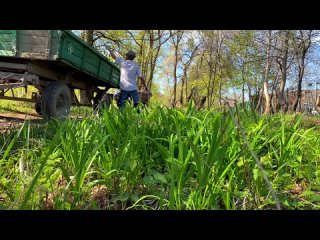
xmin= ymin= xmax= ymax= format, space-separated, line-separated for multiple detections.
xmin=108 ymin=47 xmax=148 ymax=113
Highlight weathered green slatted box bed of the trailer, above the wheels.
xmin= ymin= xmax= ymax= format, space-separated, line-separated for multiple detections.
xmin=0 ymin=30 xmax=120 ymax=88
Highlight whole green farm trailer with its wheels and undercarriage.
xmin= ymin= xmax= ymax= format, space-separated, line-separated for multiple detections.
xmin=0 ymin=30 xmax=120 ymax=116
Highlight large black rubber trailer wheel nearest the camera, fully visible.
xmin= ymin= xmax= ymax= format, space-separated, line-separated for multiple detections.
xmin=41 ymin=82 xmax=71 ymax=117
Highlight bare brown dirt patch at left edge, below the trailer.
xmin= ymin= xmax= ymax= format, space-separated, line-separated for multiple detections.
xmin=0 ymin=112 xmax=42 ymax=134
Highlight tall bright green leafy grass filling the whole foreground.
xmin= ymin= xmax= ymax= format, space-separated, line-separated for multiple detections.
xmin=0 ymin=105 xmax=320 ymax=210
